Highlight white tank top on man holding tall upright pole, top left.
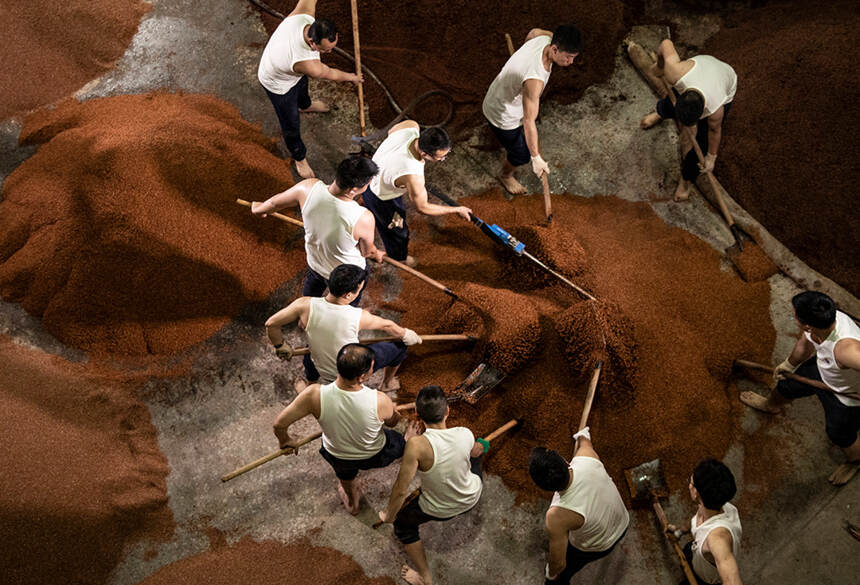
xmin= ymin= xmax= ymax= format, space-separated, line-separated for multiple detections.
xmin=257 ymin=14 xmax=320 ymax=95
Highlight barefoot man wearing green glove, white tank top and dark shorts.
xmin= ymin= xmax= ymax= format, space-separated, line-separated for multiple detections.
xmin=379 ymin=386 xmax=489 ymax=583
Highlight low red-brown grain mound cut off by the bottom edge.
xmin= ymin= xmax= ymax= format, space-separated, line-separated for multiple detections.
xmin=135 ymin=538 xmax=394 ymax=585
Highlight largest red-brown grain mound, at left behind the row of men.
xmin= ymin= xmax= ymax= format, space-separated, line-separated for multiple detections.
xmin=0 ymin=93 xmax=304 ymax=355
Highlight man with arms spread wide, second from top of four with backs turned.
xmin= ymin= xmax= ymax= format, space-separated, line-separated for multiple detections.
xmin=266 ymin=264 xmax=421 ymax=392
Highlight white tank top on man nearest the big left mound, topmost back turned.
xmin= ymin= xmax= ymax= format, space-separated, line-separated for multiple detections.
xmin=302 ymin=181 xmax=367 ymax=279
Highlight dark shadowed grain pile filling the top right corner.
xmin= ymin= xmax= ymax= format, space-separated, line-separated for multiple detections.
xmin=705 ymin=0 xmax=860 ymax=295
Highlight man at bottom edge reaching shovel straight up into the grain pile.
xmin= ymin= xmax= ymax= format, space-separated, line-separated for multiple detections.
xmin=529 ymin=427 xmax=630 ymax=585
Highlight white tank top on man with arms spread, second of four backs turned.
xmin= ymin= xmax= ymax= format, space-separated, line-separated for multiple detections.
xmin=305 ymin=297 xmax=361 ymax=384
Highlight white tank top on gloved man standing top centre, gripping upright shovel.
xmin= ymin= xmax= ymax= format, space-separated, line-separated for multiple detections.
xmin=481 ymin=35 xmax=552 ymax=130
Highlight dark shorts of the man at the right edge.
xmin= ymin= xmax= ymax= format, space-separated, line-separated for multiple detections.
xmin=776 ymin=357 xmax=860 ymax=449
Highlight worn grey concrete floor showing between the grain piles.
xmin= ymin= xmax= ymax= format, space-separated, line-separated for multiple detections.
xmin=0 ymin=0 xmax=860 ymax=585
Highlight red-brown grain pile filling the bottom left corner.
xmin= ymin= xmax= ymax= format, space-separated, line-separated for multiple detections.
xmin=0 ymin=339 xmax=173 ymax=585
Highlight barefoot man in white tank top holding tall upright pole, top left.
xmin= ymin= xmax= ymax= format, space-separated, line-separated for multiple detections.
xmin=257 ymin=0 xmax=363 ymax=179
